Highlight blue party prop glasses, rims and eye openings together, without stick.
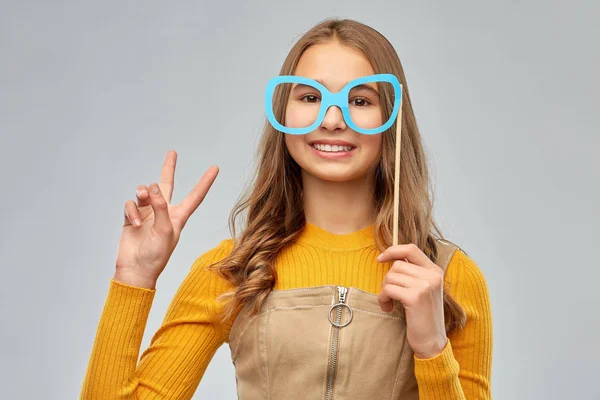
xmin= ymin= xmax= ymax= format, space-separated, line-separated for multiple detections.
xmin=265 ymin=74 xmax=402 ymax=135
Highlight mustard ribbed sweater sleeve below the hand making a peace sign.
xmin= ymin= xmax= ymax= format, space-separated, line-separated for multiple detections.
xmin=80 ymin=241 xmax=237 ymax=399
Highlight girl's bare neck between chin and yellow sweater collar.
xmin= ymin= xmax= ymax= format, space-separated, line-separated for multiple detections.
xmin=302 ymin=171 xmax=375 ymax=235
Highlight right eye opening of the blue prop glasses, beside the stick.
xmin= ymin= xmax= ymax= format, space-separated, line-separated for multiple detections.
xmin=348 ymin=82 xmax=395 ymax=129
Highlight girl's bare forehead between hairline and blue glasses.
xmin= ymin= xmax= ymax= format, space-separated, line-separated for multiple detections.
xmin=294 ymin=41 xmax=375 ymax=92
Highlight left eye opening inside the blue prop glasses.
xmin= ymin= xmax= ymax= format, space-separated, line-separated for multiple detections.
xmin=272 ymin=83 xmax=323 ymax=128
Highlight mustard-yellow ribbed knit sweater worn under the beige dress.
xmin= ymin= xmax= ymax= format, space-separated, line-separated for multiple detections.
xmin=80 ymin=222 xmax=492 ymax=400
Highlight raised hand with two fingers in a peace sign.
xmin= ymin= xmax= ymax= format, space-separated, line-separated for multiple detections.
xmin=114 ymin=150 xmax=219 ymax=289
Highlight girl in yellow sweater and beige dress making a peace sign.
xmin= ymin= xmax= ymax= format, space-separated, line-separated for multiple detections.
xmin=81 ymin=20 xmax=492 ymax=400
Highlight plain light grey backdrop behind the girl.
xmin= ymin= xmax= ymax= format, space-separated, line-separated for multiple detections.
xmin=0 ymin=0 xmax=600 ymax=399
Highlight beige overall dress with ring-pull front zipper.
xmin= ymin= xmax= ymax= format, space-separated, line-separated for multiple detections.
xmin=228 ymin=240 xmax=462 ymax=400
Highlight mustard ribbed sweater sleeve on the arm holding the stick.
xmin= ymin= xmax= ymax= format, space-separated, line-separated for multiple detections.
xmin=414 ymin=251 xmax=493 ymax=400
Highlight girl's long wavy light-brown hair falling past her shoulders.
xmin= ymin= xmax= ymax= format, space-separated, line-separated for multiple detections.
xmin=209 ymin=19 xmax=466 ymax=332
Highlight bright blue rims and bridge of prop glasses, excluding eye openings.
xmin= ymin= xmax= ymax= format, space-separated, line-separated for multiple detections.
xmin=265 ymin=74 xmax=402 ymax=135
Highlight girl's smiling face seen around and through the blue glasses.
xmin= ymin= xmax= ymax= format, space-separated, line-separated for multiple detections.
xmin=285 ymin=40 xmax=382 ymax=182
